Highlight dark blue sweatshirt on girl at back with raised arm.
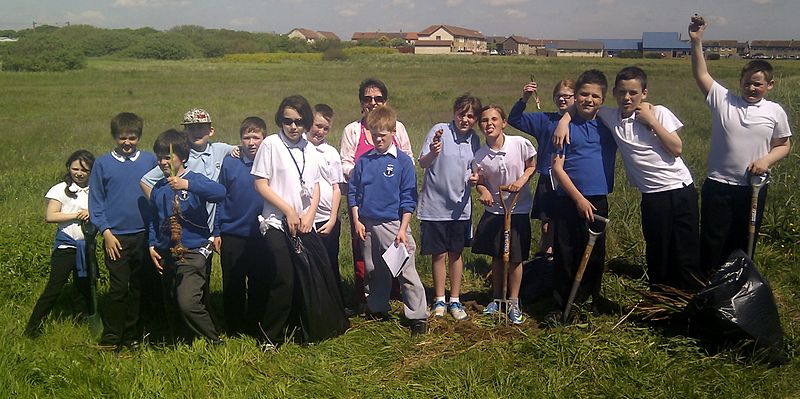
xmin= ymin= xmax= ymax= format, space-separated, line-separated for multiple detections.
xmin=508 ymin=100 xmax=561 ymax=176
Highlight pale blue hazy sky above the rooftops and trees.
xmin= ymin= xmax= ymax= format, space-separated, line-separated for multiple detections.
xmin=0 ymin=0 xmax=800 ymax=41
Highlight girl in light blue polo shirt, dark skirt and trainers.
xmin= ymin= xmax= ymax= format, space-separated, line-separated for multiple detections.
xmin=417 ymin=94 xmax=483 ymax=320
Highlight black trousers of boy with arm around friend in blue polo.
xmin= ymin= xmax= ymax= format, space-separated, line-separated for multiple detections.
xmin=641 ymin=184 xmax=703 ymax=289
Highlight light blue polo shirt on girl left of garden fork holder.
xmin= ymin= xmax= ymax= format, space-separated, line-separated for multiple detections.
xmin=417 ymin=122 xmax=481 ymax=221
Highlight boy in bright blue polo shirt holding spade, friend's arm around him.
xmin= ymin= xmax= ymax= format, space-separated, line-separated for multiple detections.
xmin=552 ymin=69 xmax=617 ymax=318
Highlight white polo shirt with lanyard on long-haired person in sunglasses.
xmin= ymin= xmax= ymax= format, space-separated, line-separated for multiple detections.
xmin=250 ymin=133 xmax=319 ymax=233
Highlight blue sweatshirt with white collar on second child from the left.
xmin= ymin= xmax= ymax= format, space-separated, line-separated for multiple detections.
xmin=89 ymin=151 xmax=156 ymax=235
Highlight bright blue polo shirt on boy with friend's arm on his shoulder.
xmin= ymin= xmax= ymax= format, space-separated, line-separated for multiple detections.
xmin=558 ymin=115 xmax=617 ymax=197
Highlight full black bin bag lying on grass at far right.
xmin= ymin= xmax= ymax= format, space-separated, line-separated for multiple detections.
xmin=686 ymin=250 xmax=785 ymax=363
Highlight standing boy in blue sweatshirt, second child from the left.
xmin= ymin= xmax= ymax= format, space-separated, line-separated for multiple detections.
xmin=89 ymin=112 xmax=156 ymax=349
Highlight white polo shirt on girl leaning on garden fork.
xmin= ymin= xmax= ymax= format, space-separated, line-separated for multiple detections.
xmin=473 ymin=135 xmax=536 ymax=215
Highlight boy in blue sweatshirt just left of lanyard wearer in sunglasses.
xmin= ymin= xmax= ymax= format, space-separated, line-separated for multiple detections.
xmin=214 ymin=116 xmax=268 ymax=334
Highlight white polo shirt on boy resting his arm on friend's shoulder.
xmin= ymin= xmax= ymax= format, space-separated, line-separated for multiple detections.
xmin=597 ymin=105 xmax=692 ymax=194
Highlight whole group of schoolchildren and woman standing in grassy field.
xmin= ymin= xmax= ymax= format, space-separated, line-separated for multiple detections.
xmin=26 ymin=15 xmax=791 ymax=348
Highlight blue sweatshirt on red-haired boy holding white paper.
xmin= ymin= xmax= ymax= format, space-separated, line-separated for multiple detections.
xmin=347 ymin=145 xmax=417 ymax=222
